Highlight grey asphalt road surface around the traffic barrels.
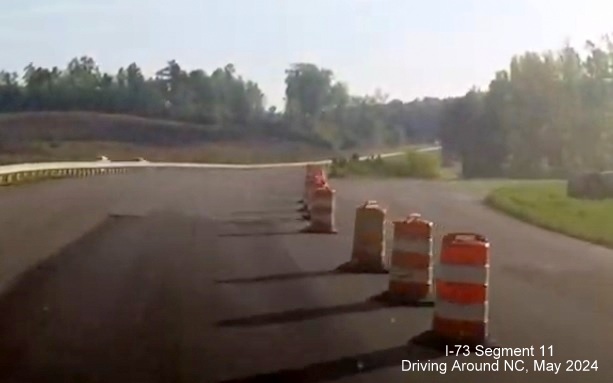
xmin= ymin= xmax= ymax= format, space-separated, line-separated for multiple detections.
xmin=0 ymin=169 xmax=613 ymax=383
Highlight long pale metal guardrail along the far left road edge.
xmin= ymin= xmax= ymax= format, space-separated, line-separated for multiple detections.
xmin=0 ymin=146 xmax=440 ymax=184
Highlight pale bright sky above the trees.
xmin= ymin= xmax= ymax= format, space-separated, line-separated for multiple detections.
xmin=0 ymin=0 xmax=613 ymax=108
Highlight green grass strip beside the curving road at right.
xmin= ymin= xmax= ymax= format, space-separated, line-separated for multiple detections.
xmin=485 ymin=181 xmax=613 ymax=247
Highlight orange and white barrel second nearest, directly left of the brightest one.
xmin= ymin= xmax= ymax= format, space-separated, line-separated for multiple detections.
xmin=387 ymin=214 xmax=434 ymax=302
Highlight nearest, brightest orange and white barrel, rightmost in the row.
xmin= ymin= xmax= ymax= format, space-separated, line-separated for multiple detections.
xmin=432 ymin=233 xmax=490 ymax=344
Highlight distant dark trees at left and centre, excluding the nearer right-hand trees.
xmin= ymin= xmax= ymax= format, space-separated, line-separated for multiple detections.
xmin=0 ymin=56 xmax=442 ymax=149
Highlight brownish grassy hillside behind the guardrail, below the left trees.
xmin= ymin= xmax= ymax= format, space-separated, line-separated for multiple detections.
xmin=0 ymin=112 xmax=333 ymax=163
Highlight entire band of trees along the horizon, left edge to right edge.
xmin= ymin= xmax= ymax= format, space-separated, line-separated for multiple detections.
xmin=5 ymin=33 xmax=613 ymax=177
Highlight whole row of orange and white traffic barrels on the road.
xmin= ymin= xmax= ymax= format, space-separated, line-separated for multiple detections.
xmin=303 ymin=165 xmax=490 ymax=344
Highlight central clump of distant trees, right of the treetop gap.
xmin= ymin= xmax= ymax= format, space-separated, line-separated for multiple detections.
xmin=284 ymin=63 xmax=443 ymax=149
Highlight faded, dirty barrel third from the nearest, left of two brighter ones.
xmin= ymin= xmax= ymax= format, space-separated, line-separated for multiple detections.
xmin=339 ymin=201 xmax=387 ymax=273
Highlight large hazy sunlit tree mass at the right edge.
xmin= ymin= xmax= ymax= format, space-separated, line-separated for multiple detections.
xmin=440 ymin=37 xmax=613 ymax=178
